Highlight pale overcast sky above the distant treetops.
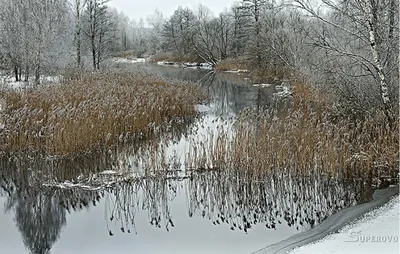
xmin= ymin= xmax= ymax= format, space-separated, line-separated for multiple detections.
xmin=109 ymin=0 xmax=235 ymax=22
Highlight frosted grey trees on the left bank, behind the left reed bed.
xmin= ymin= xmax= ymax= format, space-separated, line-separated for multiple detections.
xmin=0 ymin=0 xmax=152 ymax=83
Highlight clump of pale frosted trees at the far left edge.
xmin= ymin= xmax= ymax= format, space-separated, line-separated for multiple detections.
xmin=0 ymin=0 xmax=69 ymax=83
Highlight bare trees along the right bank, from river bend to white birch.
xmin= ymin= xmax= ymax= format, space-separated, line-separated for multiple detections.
xmin=155 ymin=0 xmax=399 ymax=120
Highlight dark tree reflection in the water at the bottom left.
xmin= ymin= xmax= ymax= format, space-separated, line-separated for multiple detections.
xmin=0 ymin=159 xmax=98 ymax=254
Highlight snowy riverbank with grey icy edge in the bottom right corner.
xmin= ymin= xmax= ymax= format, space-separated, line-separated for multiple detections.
xmin=253 ymin=185 xmax=399 ymax=254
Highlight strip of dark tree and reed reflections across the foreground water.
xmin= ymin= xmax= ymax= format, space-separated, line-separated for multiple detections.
xmin=0 ymin=157 xmax=365 ymax=240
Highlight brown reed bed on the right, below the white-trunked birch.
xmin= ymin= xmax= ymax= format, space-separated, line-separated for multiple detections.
xmin=190 ymin=83 xmax=399 ymax=179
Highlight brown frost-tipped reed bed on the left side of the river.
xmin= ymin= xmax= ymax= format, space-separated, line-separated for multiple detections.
xmin=0 ymin=71 xmax=204 ymax=155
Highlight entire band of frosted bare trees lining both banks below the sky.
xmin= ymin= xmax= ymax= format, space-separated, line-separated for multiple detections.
xmin=0 ymin=0 xmax=399 ymax=119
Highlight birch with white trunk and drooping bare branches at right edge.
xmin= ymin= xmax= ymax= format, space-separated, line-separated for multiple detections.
xmin=294 ymin=0 xmax=399 ymax=122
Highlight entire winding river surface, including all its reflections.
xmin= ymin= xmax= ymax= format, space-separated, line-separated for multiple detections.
xmin=0 ymin=64 xmax=364 ymax=254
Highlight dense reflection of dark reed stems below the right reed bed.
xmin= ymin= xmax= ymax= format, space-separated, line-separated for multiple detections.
xmin=186 ymin=170 xmax=363 ymax=232
